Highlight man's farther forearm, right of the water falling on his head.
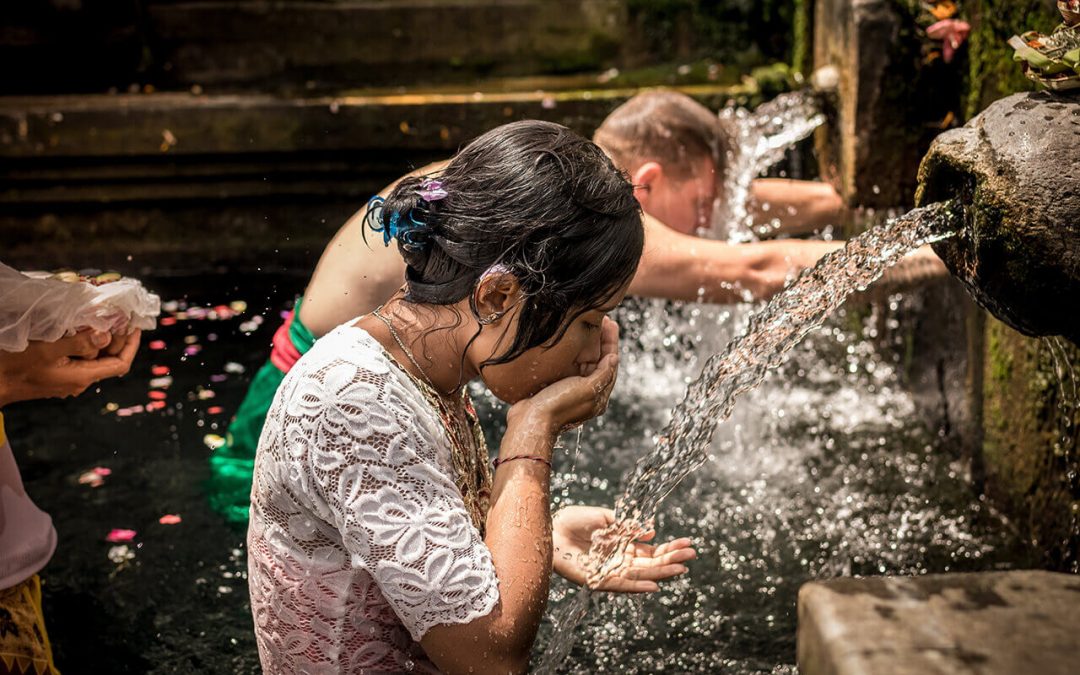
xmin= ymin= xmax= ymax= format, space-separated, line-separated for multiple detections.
xmin=751 ymin=178 xmax=846 ymax=237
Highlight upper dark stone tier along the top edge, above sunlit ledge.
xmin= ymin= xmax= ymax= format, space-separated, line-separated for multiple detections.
xmin=0 ymin=0 xmax=626 ymax=92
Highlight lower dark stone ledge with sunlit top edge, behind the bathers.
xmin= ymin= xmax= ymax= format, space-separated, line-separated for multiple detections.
xmin=0 ymin=79 xmax=755 ymax=268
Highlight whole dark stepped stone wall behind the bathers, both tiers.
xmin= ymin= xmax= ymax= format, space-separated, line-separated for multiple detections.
xmin=0 ymin=0 xmax=787 ymax=274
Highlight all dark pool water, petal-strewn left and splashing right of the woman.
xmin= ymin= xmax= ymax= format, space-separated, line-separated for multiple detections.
xmin=5 ymin=270 xmax=1026 ymax=674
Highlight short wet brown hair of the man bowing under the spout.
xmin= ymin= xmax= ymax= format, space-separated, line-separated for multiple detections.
xmin=593 ymin=90 xmax=731 ymax=180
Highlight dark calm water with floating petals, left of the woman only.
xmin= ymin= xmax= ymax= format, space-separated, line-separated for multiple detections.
xmin=4 ymin=273 xmax=306 ymax=674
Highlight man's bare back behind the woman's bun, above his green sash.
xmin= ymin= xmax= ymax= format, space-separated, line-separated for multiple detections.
xmin=300 ymin=161 xmax=448 ymax=337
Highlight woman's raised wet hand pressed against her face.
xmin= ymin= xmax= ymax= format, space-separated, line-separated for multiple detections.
xmin=507 ymin=316 xmax=619 ymax=434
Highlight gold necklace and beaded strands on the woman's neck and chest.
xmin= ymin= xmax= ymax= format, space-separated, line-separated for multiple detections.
xmin=372 ymin=305 xmax=491 ymax=537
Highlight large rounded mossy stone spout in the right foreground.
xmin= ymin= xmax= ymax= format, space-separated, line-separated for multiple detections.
xmin=916 ymin=93 xmax=1080 ymax=345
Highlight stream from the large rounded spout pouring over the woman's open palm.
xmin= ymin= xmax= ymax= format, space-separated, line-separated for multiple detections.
xmin=537 ymin=198 xmax=959 ymax=673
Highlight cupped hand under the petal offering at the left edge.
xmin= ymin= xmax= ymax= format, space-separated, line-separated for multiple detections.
xmin=0 ymin=330 xmax=141 ymax=407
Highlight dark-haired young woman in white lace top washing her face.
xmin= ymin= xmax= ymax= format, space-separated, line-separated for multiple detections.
xmin=247 ymin=121 xmax=694 ymax=673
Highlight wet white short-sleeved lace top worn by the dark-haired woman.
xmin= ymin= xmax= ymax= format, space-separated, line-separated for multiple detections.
xmin=247 ymin=325 xmax=499 ymax=674
